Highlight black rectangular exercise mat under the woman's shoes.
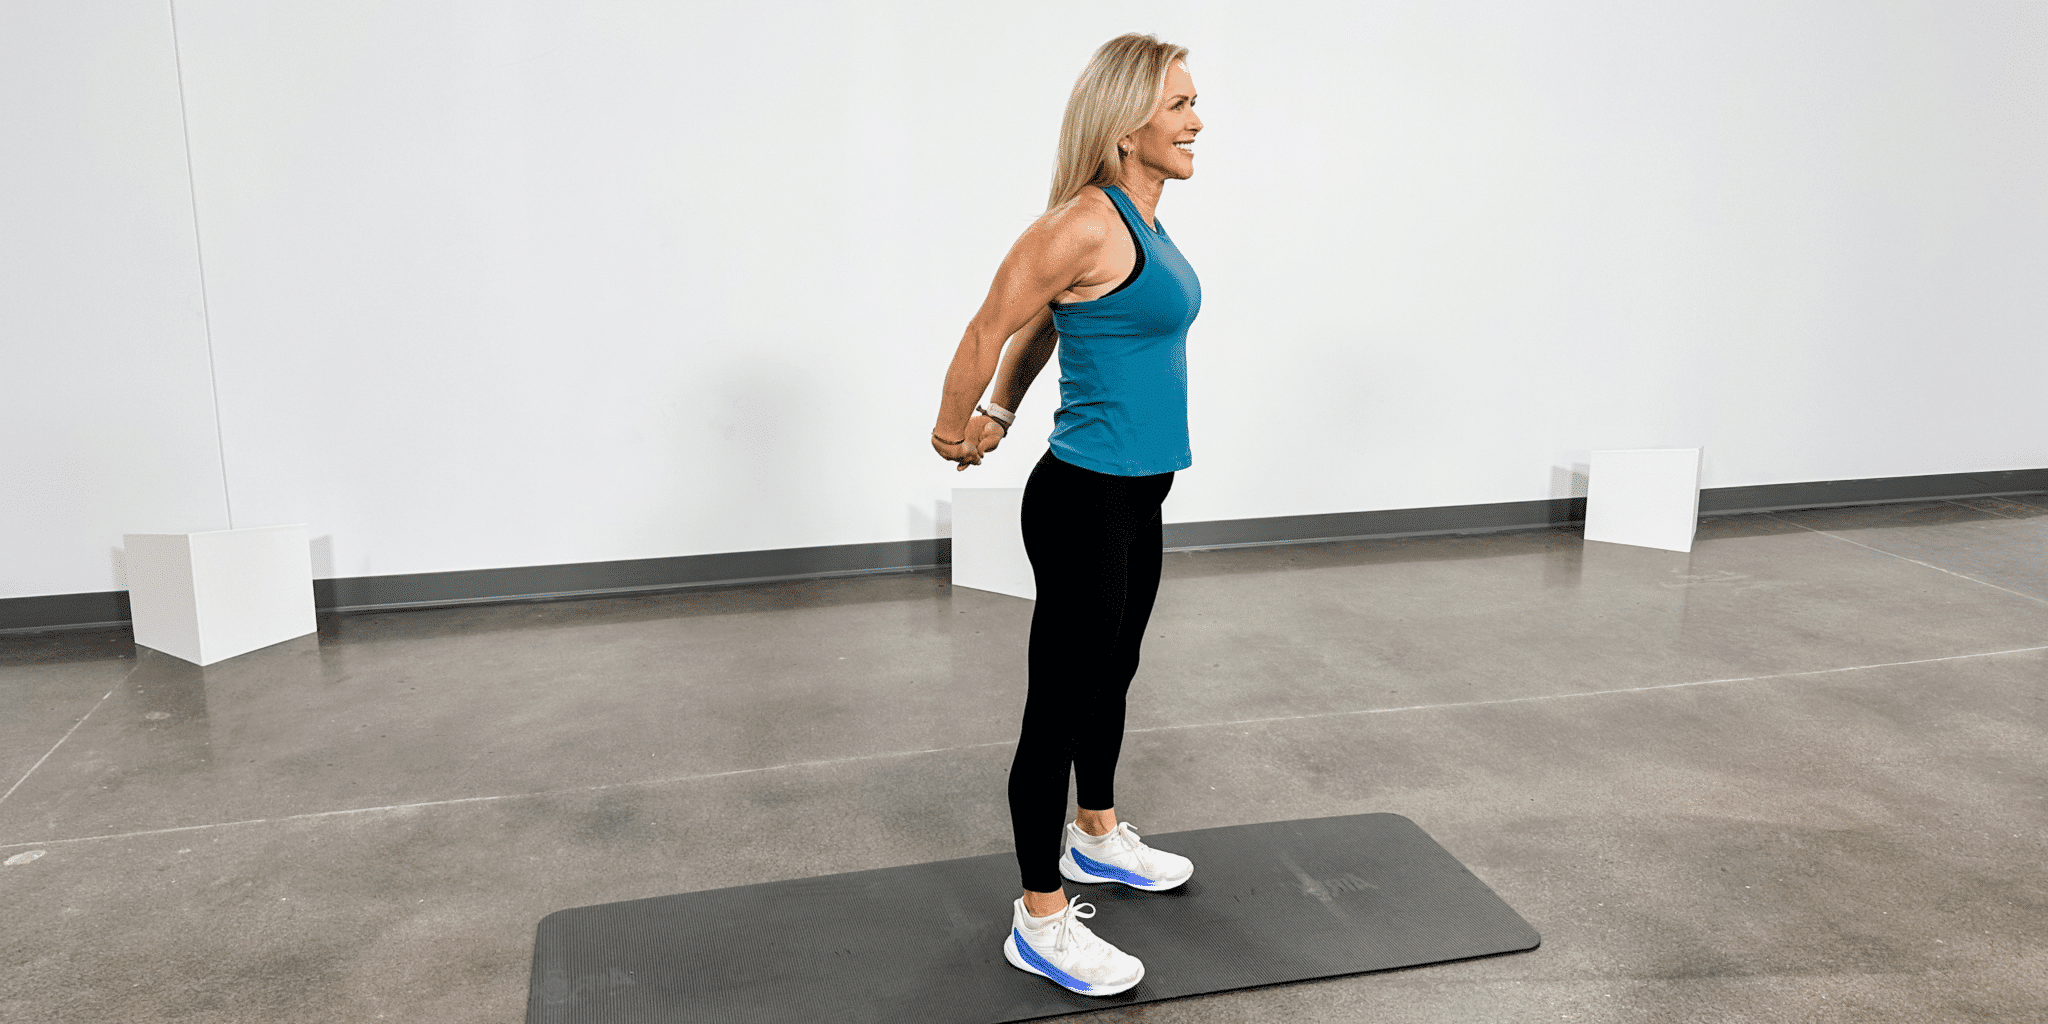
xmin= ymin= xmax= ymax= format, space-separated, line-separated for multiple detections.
xmin=526 ymin=815 xmax=1540 ymax=1024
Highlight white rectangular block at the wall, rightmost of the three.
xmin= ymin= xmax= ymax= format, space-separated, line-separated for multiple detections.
xmin=1585 ymin=449 xmax=1700 ymax=551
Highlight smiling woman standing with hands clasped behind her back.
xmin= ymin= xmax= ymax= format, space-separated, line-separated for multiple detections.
xmin=932 ymin=35 xmax=1202 ymax=995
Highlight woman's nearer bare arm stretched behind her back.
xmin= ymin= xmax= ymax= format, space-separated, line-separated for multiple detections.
xmin=932 ymin=203 xmax=1108 ymax=442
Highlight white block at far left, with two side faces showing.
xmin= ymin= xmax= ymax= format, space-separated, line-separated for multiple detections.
xmin=125 ymin=522 xmax=319 ymax=666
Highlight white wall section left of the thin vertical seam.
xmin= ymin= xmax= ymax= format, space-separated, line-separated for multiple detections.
xmin=0 ymin=2 xmax=225 ymax=598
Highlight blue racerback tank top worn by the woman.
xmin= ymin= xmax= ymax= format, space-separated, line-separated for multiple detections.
xmin=1051 ymin=184 xmax=1202 ymax=477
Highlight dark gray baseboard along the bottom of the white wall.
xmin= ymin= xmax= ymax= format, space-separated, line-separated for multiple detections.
xmin=0 ymin=469 xmax=2048 ymax=635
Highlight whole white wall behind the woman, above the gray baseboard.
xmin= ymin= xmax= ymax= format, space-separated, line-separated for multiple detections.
xmin=0 ymin=0 xmax=2048 ymax=596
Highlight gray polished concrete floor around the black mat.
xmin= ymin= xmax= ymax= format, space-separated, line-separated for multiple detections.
xmin=0 ymin=496 xmax=2048 ymax=1024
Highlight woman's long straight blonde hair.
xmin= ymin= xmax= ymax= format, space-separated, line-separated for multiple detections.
xmin=1044 ymin=33 xmax=1188 ymax=209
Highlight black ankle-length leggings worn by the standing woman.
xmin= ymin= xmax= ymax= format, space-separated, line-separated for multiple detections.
xmin=1010 ymin=449 xmax=1174 ymax=893
